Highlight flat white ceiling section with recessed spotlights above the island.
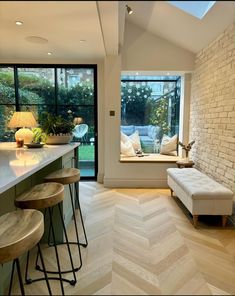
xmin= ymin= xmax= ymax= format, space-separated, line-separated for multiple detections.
xmin=0 ymin=1 xmax=105 ymax=62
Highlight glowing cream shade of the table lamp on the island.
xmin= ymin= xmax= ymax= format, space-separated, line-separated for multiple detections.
xmin=8 ymin=112 xmax=37 ymax=128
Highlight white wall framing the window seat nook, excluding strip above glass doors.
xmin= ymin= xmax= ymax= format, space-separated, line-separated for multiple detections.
xmin=101 ymin=24 xmax=194 ymax=188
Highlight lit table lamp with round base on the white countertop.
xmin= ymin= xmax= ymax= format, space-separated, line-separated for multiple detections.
xmin=8 ymin=112 xmax=37 ymax=144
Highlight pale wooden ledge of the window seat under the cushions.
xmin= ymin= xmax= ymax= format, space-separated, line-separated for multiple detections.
xmin=120 ymin=153 xmax=182 ymax=163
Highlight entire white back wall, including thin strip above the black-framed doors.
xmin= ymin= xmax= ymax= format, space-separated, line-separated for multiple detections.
xmin=1 ymin=20 xmax=194 ymax=187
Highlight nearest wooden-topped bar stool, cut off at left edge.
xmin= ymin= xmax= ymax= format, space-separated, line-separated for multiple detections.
xmin=0 ymin=210 xmax=52 ymax=295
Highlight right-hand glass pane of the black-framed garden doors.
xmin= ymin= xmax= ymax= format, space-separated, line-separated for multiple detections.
xmin=57 ymin=68 xmax=95 ymax=176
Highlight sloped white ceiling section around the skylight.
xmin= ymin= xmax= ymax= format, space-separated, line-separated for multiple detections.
xmin=127 ymin=1 xmax=235 ymax=53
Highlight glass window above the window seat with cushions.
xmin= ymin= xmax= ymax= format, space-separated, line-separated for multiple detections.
xmin=121 ymin=75 xmax=180 ymax=153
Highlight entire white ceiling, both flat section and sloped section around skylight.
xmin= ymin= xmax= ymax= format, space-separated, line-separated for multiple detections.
xmin=0 ymin=1 xmax=235 ymax=63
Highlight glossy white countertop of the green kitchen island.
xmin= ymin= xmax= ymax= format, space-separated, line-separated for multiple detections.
xmin=0 ymin=142 xmax=79 ymax=193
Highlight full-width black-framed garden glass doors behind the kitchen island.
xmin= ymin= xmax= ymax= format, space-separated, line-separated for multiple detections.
xmin=0 ymin=65 xmax=97 ymax=177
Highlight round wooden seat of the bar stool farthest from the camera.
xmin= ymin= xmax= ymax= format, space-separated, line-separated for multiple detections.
xmin=45 ymin=168 xmax=80 ymax=185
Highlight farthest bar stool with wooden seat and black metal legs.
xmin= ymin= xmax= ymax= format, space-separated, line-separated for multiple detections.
xmin=45 ymin=168 xmax=88 ymax=270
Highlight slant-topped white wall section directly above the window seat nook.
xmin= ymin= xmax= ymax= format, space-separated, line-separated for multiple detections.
xmin=121 ymin=22 xmax=195 ymax=72
